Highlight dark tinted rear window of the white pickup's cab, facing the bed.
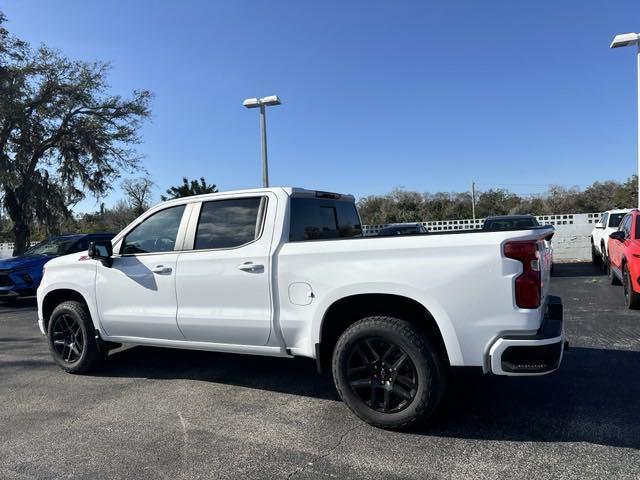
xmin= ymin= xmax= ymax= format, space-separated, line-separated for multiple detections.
xmin=289 ymin=196 xmax=362 ymax=242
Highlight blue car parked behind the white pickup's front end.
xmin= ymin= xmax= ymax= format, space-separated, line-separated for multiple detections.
xmin=0 ymin=233 xmax=114 ymax=302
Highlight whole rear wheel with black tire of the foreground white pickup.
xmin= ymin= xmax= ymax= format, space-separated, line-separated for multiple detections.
xmin=332 ymin=316 xmax=448 ymax=430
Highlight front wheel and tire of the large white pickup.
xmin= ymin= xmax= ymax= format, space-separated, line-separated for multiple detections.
xmin=47 ymin=300 xmax=108 ymax=373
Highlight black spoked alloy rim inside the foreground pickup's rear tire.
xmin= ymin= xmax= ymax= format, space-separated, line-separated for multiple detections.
xmin=347 ymin=337 xmax=418 ymax=413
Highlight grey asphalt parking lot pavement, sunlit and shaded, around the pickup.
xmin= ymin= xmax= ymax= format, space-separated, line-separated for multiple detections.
xmin=0 ymin=264 xmax=640 ymax=480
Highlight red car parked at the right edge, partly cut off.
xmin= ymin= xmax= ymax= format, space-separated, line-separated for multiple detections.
xmin=607 ymin=209 xmax=640 ymax=308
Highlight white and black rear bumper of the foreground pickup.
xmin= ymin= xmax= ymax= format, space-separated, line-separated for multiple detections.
xmin=488 ymin=296 xmax=565 ymax=376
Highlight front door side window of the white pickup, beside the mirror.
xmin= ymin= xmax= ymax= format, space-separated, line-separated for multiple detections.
xmin=120 ymin=205 xmax=185 ymax=255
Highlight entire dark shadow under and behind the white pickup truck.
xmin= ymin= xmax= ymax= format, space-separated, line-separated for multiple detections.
xmin=97 ymin=347 xmax=640 ymax=449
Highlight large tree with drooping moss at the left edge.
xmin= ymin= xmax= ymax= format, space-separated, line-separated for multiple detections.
xmin=0 ymin=12 xmax=151 ymax=254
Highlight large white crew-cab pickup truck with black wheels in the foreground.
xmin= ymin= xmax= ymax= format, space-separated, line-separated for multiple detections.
xmin=38 ymin=188 xmax=565 ymax=428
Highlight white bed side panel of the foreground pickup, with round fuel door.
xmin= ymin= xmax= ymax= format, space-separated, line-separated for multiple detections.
xmin=277 ymin=231 xmax=548 ymax=366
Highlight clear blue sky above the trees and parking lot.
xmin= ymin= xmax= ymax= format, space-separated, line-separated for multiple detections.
xmin=1 ymin=0 xmax=640 ymax=209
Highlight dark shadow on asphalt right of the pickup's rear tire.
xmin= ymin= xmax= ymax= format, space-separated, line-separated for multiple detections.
xmin=422 ymin=348 xmax=640 ymax=449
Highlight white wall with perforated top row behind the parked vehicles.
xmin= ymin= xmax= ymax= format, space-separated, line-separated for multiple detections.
xmin=0 ymin=213 xmax=600 ymax=262
